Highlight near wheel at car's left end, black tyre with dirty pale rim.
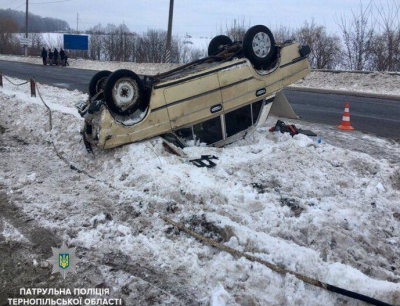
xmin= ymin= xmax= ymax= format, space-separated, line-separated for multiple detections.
xmin=104 ymin=69 xmax=144 ymax=116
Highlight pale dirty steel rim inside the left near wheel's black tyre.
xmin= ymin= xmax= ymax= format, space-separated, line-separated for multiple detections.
xmin=112 ymin=78 xmax=139 ymax=110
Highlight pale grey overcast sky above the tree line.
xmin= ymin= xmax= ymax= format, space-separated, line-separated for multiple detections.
xmin=0 ymin=0 xmax=376 ymax=37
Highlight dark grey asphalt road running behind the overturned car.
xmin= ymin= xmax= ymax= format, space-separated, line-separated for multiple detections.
xmin=0 ymin=61 xmax=400 ymax=140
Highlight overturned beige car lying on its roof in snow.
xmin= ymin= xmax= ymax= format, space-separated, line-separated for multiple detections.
xmin=77 ymin=25 xmax=310 ymax=149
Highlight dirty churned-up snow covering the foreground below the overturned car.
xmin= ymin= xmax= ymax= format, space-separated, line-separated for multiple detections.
xmin=0 ymin=75 xmax=400 ymax=306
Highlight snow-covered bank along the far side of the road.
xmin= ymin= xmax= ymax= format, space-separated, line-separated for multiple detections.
xmin=0 ymin=55 xmax=400 ymax=96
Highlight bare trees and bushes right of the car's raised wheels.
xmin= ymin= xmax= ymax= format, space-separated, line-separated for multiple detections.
xmin=276 ymin=0 xmax=400 ymax=71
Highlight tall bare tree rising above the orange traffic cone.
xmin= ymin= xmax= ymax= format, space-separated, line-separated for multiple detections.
xmin=337 ymin=0 xmax=374 ymax=70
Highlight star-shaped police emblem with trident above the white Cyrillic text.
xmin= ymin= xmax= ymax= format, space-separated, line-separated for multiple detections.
xmin=47 ymin=242 xmax=79 ymax=279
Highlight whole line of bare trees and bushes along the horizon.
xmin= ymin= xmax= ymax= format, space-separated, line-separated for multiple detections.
xmin=0 ymin=0 xmax=400 ymax=71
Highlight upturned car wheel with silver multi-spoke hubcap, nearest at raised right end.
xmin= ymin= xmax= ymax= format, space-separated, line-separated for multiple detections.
xmin=243 ymin=25 xmax=276 ymax=69
